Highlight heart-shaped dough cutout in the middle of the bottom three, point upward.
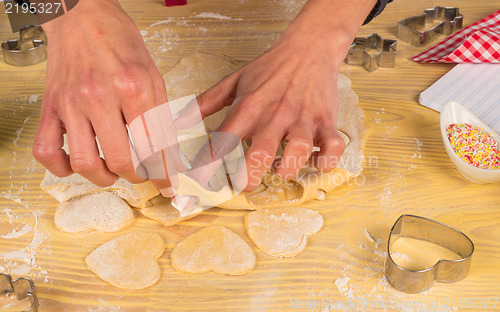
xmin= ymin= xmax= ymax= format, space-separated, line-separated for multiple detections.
xmin=170 ymin=225 xmax=255 ymax=275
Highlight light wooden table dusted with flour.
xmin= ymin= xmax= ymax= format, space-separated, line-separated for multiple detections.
xmin=0 ymin=0 xmax=500 ymax=311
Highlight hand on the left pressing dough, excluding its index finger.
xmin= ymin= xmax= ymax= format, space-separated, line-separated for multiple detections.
xmin=33 ymin=0 xmax=175 ymax=196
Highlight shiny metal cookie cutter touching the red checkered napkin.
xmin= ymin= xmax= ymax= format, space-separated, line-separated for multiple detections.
xmin=398 ymin=6 xmax=464 ymax=47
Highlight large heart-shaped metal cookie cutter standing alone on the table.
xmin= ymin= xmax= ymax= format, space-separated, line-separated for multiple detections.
xmin=385 ymin=214 xmax=474 ymax=293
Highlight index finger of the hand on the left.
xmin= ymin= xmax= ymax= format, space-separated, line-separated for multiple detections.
xmin=118 ymin=67 xmax=183 ymax=196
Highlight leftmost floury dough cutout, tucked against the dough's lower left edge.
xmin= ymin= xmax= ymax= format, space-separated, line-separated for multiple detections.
xmin=54 ymin=192 xmax=134 ymax=234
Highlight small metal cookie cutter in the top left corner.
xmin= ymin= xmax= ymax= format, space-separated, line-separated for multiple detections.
xmin=2 ymin=26 xmax=47 ymax=66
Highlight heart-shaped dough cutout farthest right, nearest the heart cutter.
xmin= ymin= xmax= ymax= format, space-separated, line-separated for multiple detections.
xmin=245 ymin=207 xmax=323 ymax=257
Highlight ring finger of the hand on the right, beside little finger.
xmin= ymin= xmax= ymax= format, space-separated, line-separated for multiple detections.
xmin=273 ymin=125 xmax=313 ymax=180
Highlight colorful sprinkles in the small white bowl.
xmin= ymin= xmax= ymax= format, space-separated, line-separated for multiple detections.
xmin=446 ymin=123 xmax=500 ymax=169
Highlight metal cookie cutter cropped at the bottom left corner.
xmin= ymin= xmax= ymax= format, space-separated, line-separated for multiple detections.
xmin=0 ymin=273 xmax=39 ymax=312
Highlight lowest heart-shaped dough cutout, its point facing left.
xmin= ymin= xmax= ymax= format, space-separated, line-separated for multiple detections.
xmin=85 ymin=233 xmax=165 ymax=289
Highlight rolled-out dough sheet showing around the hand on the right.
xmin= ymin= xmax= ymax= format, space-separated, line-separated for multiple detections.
xmin=163 ymin=53 xmax=365 ymax=210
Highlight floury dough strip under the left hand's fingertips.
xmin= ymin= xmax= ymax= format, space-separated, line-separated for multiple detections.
xmin=40 ymin=170 xmax=160 ymax=208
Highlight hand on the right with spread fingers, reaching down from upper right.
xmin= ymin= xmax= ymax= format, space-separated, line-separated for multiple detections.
xmin=198 ymin=0 xmax=375 ymax=191
